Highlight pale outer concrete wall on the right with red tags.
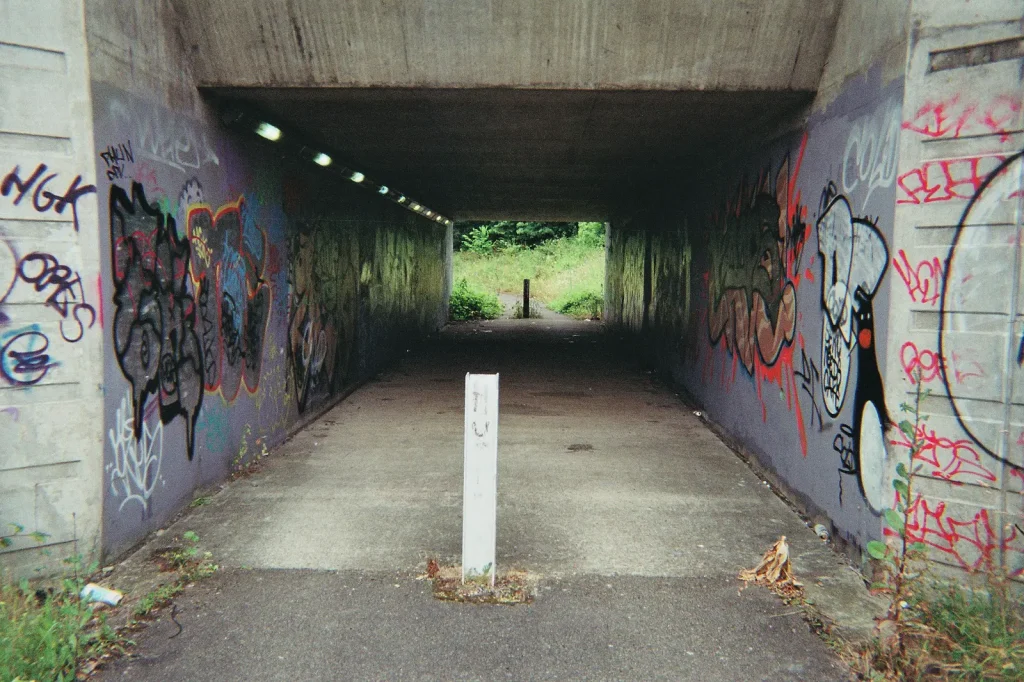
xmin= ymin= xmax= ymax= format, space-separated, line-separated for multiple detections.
xmin=885 ymin=0 xmax=1024 ymax=574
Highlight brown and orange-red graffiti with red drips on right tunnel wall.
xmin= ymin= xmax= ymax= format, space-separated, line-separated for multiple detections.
xmin=708 ymin=153 xmax=808 ymax=373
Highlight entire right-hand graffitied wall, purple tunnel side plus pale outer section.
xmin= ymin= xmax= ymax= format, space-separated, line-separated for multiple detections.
xmin=608 ymin=0 xmax=1024 ymax=577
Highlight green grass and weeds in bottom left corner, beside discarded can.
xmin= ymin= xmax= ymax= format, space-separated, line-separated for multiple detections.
xmin=0 ymin=557 xmax=122 ymax=682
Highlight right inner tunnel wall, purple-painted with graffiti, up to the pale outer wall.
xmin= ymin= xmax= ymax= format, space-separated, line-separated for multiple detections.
xmin=607 ymin=2 xmax=907 ymax=561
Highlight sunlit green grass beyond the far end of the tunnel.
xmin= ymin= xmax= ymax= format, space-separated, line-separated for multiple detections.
xmin=453 ymin=237 xmax=604 ymax=303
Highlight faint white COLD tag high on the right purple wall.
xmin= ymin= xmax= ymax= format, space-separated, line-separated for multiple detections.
xmin=843 ymin=104 xmax=901 ymax=206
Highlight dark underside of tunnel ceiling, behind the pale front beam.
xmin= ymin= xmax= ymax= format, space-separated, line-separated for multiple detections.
xmin=215 ymin=88 xmax=810 ymax=220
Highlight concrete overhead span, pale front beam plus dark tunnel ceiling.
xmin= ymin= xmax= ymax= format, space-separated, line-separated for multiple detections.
xmin=182 ymin=0 xmax=840 ymax=219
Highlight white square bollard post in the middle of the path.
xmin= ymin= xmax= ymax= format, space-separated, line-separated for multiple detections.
xmin=462 ymin=374 xmax=498 ymax=587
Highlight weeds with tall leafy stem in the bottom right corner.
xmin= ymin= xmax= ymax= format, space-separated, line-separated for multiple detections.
xmin=851 ymin=373 xmax=1024 ymax=680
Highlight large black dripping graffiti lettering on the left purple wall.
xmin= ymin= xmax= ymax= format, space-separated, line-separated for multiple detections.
xmin=110 ymin=182 xmax=204 ymax=460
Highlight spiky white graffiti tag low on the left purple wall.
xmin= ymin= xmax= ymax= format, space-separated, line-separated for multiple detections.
xmin=105 ymin=391 xmax=164 ymax=511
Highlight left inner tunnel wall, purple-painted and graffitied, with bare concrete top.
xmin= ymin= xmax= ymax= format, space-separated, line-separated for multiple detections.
xmin=88 ymin=2 xmax=449 ymax=554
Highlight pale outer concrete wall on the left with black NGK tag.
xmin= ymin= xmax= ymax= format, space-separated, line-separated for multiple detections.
xmin=0 ymin=0 xmax=103 ymax=573
